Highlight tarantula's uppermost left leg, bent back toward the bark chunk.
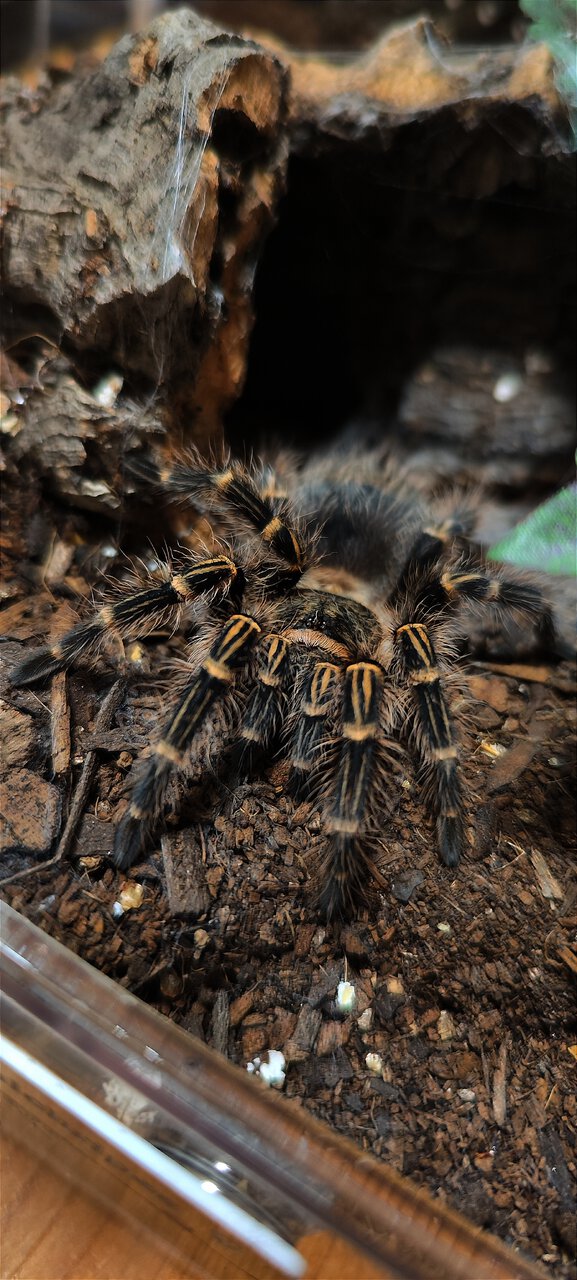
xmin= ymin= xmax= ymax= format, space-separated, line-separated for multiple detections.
xmin=151 ymin=461 xmax=308 ymax=586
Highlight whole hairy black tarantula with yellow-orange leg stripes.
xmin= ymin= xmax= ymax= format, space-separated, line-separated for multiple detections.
xmin=13 ymin=454 xmax=553 ymax=916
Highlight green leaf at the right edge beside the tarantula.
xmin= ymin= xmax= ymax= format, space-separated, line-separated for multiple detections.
xmin=489 ymin=484 xmax=577 ymax=576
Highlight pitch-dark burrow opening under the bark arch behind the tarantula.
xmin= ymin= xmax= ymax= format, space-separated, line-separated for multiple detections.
xmin=228 ymin=108 xmax=576 ymax=485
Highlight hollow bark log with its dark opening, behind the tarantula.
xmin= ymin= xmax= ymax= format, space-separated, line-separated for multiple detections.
xmin=4 ymin=10 xmax=574 ymax=501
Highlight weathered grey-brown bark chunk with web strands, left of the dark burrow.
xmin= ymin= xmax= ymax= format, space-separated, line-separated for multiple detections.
xmin=4 ymin=10 xmax=285 ymax=440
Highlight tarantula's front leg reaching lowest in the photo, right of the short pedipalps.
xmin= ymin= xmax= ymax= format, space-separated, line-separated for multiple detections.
xmin=320 ymin=662 xmax=383 ymax=919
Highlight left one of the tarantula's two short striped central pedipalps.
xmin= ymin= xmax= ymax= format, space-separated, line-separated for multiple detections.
xmin=237 ymin=632 xmax=289 ymax=769
